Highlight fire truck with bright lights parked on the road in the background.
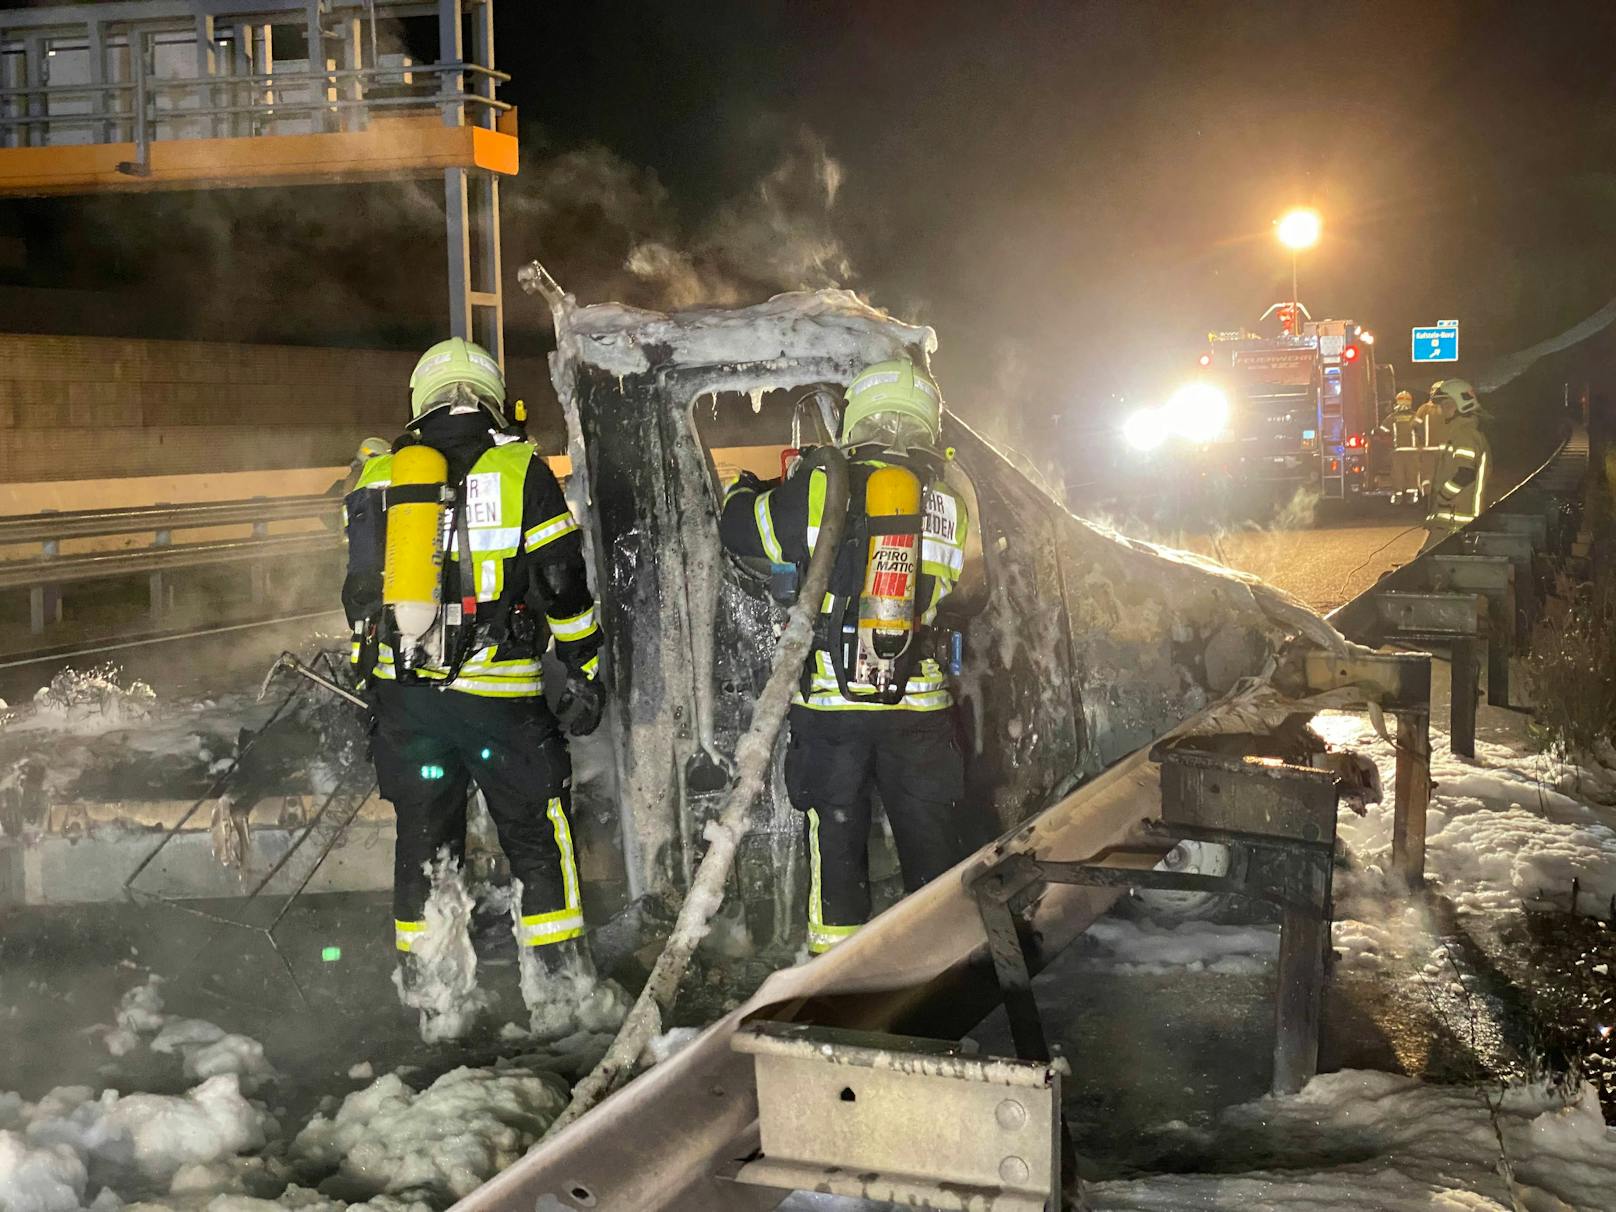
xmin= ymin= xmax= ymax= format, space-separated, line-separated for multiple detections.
xmin=1201 ymin=315 xmax=1395 ymax=499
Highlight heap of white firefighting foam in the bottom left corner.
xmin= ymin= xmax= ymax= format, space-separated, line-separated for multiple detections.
xmin=0 ymin=978 xmax=567 ymax=1212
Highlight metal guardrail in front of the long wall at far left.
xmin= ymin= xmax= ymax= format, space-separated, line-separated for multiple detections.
xmin=0 ymin=494 xmax=343 ymax=635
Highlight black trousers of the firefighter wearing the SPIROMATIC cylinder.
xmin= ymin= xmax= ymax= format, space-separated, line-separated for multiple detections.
xmin=785 ymin=706 xmax=965 ymax=952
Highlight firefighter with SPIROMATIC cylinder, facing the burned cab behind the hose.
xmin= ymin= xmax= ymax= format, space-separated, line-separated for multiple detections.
xmin=722 ymin=360 xmax=970 ymax=953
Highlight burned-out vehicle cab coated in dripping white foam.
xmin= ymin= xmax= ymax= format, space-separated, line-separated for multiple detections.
xmin=525 ymin=271 xmax=1299 ymax=950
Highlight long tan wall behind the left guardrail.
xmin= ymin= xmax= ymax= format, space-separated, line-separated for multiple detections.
xmin=0 ymin=333 xmax=559 ymax=512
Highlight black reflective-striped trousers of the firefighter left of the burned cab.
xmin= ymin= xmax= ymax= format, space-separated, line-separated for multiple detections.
xmin=370 ymin=682 xmax=583 ymax=952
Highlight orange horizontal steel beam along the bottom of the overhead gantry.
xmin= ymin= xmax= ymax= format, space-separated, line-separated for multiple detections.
xmin=0 ymin=112 xmax=517 ymax=197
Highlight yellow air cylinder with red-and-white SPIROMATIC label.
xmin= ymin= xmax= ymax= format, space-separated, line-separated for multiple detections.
xmin=853 ymin=467 xmax=921 ymax=690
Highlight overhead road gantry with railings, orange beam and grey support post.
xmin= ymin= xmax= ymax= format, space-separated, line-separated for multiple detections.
xmin=0 ymin=0 xmax=517 ymax=362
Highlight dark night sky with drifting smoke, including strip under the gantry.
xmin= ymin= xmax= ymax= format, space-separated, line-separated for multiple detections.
xmin=0 ymin=0 xmax=1616 ymax=452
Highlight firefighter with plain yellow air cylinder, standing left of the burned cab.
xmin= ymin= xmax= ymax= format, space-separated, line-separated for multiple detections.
xmin=343 ymin=338 xmax=603 ymax=991
